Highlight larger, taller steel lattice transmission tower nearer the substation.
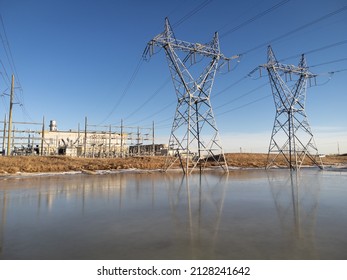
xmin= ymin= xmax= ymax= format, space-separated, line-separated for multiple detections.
xmin=144 ymin=18 xmax=238 ymax=174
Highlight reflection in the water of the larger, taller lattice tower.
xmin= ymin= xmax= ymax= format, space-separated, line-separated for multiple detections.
xmin=167 ymin=173 xmax=228 ymax=259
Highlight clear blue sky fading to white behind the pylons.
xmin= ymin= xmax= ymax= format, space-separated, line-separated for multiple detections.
xmin=0 ymin=0 xmax=347 ymax=153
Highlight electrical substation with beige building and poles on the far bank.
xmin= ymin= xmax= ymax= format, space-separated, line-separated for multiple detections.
xmin=0 ymin=118 xmax=167 ymax=158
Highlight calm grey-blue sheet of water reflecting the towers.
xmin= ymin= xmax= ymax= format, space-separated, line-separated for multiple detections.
xmin=0 ymin=169 xmax=347 ymax=260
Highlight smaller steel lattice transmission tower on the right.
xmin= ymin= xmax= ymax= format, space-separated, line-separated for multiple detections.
xmin=260 ymin=46 xmax=323 ymax=170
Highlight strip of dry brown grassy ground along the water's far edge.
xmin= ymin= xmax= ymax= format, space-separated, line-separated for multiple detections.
xmin=0 ymin=153 xmax=347 ymax=175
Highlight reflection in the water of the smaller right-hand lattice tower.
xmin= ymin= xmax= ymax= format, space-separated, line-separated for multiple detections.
xmin=268 ymin=171 xmax=321 ymax=259
